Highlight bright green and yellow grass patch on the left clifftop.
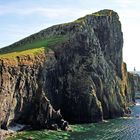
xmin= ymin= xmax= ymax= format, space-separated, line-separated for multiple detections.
xmin=0 ymin=35 xmax=67 ymax=58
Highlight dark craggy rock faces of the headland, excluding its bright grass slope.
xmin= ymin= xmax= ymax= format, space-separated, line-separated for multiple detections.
xmin=0 ymin=10 xmax=138 ymax=128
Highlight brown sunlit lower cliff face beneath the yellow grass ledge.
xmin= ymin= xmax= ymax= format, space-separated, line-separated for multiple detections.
xmin=0 ymin=54 xmax=62 ymax=129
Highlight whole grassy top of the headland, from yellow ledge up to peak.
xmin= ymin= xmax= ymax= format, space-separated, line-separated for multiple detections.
xmin=0 ymin=10 xmax=117 ymax=59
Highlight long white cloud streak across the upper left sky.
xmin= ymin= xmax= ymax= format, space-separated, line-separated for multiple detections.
xmin=0 ymin=5 xmax=91 ymax=19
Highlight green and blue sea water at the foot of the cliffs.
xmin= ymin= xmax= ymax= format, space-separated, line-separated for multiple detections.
xmin=8 ymin=99 xmax=140 ymax=140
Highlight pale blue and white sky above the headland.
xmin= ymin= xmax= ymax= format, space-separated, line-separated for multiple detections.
xmin=0 ymin=0 xmax=140 ymax=71
